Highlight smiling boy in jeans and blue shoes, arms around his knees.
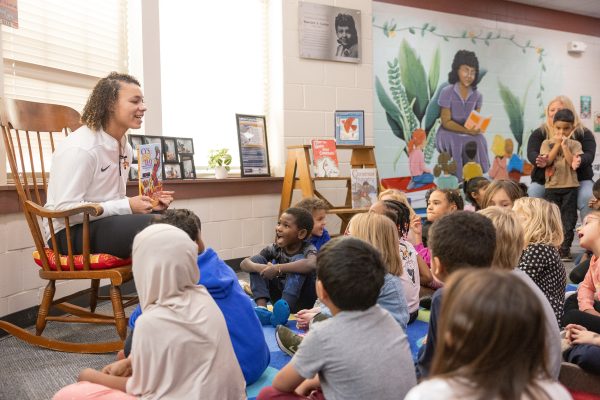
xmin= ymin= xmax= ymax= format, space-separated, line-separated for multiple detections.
xmin=240 ymin=207 xmax=317 ymax=326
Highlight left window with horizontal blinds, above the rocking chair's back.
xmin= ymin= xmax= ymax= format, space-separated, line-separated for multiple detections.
xmin=2 ymin=0 xmax=127 ymax=112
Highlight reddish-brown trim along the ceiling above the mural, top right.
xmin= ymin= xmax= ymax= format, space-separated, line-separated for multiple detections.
xmin=378 ymin=0 xmax=600 ymax=36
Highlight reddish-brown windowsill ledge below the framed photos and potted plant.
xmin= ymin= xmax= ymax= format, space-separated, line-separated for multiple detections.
xmin=0 ymin=177 xmax=283 ymax=215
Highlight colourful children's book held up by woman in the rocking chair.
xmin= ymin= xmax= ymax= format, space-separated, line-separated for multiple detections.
xmin=137 ymin=143 xmax=162 ymax=206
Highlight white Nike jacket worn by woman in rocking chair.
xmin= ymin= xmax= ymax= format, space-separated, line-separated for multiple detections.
xmin=44 ymin=125 xmax=132 ymax=237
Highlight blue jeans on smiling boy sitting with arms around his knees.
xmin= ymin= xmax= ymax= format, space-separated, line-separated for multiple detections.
xmin=250 ymin=254 xmax=317 ymax=313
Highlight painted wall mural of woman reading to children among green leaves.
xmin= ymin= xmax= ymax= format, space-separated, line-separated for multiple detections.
xmin=373 ymin=3 xmax=559 ymax=208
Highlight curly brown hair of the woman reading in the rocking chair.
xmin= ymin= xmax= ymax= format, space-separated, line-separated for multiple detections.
xmin=81 ymin=72 xmax=141 ymax=130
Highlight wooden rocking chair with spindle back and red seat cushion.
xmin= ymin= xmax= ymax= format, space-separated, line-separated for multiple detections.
xmin=0 ymin=99 xmax=137 ymax=353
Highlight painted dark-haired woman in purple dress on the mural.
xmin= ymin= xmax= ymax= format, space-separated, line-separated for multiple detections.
xmin=436 ymin=50 xmax=490 ymax=180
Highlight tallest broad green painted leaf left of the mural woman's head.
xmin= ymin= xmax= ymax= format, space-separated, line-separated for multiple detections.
xmin=398 ymin=40 xmax=429 ymax=121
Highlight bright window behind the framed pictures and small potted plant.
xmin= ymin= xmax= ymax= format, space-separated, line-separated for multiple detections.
xmin=158 ymin=0 xmax=268 ymax=167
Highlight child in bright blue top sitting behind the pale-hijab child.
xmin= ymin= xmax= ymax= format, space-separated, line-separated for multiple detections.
xmin=125 ymin=209 xmax=271 ymax=385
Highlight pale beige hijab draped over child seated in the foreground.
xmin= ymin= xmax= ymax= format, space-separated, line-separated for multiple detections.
xmin=127 ymin=224 xmax=246 ymax=400
